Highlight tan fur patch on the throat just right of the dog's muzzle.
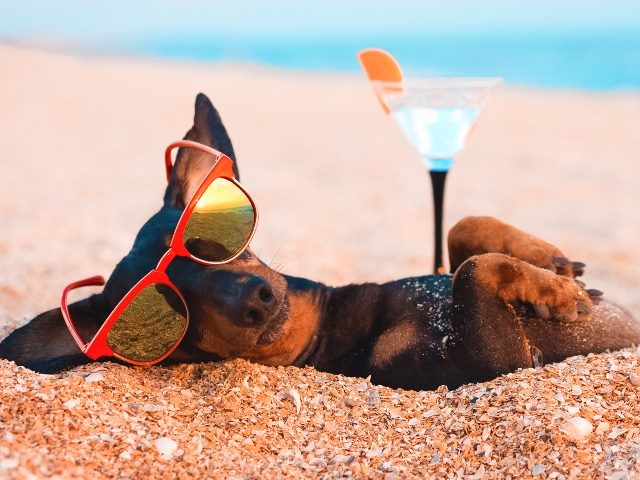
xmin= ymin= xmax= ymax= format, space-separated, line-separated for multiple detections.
xmin=242 ymin=293 xmax=320 ymax=366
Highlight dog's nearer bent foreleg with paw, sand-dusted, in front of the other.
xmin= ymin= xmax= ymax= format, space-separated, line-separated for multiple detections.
xmin=449 ymin=253 xmax=592 ymax=381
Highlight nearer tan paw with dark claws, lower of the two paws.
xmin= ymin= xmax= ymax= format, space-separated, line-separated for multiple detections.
xmin=532 ymin=276 xmax=602 ymax=322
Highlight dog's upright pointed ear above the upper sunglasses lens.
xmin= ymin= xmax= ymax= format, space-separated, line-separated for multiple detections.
xmin=164 ymin=93 xmax=240 ymax=209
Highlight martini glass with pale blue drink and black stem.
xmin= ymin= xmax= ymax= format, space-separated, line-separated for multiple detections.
xmin=371 ymin=77 xmax=501 ymax=274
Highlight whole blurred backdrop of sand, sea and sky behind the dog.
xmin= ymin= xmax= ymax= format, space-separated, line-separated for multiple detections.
xmin=0 ymin=0 xmax=640 ymax=326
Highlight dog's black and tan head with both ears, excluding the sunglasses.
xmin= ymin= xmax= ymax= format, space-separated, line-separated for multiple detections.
xmin=0 ymin=94 xmax=323 ymax=372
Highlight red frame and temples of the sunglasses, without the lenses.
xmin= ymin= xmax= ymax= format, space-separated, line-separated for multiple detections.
xmin=60 ymin=140 xmax=258 ymax=366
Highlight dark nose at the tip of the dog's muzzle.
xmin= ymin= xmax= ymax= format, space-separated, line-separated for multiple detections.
xmin=232 ymin=275 xmax=278 ymax=327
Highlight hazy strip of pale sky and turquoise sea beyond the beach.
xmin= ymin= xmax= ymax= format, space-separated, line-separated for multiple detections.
xmin=0 ymin=0 xmax=640 ymax=90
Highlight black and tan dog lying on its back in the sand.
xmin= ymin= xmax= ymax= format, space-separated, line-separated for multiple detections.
xmin=0 ymin=94 xmax=640 ymax=390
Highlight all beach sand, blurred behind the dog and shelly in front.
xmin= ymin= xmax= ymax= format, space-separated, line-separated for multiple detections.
xmin=0 ymin=45 xmax=640 ymax=478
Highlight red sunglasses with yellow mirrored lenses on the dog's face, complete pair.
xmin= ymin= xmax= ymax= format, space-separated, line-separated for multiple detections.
xmin=60 ymin=140 xmax=258 ymax=365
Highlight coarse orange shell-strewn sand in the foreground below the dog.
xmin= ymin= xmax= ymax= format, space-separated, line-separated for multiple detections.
xmin=0 ymin=349 xmax=640 ymax=479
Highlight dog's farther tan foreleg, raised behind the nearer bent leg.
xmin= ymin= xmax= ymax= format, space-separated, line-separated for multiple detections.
xmin=447 ymin=217 xmax=585 ymax=277
